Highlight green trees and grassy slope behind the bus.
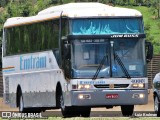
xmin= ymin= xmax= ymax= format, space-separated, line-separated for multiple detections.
xmin=0 ymin=0 xmax=160 ymax=54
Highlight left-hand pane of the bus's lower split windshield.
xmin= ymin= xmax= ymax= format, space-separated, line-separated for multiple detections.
xmin=72 ymin=39 xmax=109 ymax=78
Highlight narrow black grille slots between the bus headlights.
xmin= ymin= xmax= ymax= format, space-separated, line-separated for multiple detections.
xmin=94 ymin=84 xmax=129 ymax=88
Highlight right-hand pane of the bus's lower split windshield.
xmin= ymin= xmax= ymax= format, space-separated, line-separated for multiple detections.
xmin=112 ymin=39 xmax=146 ymax=77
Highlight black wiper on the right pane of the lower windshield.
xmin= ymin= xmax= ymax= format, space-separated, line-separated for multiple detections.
xmin=114 ymin=51 xmax=131 ymax=79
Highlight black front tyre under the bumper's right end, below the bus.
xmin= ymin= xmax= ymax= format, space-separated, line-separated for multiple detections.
xmin=121 ymin=105 xmax=134 ymax=116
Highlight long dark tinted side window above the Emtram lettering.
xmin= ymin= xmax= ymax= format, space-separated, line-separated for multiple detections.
xmin=6 ymin=19 xmax=59 ymax=55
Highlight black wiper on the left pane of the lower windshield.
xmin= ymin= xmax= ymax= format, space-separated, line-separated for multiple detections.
xmin=92 ymin=54 xmax=108 ymax=80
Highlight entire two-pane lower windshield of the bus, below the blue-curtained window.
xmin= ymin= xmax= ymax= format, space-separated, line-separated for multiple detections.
xmin=71 ymin=39 xmax=146 ymax=78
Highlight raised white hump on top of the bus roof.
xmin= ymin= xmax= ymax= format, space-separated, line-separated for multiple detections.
xmin=38 ymin=2 xmax=142 ymax=17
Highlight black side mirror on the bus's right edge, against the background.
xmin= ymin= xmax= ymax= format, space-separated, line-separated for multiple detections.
xmin=146 ymin=42 xmax=153 ymax=63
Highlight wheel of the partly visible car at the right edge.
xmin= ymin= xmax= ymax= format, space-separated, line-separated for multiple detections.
xmin=154 ymin=95 xmax=160 ymax=117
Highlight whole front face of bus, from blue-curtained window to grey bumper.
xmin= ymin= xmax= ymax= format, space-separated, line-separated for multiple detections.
xmin=62 ymin=17 xmax=148 ymax=106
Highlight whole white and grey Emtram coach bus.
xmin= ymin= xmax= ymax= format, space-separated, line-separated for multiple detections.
xmin=2 ymin=2 xmax=153 ymax=117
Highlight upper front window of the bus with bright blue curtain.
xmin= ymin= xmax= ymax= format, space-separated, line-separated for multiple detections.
xmin=71 ymin=18 xmax=144 ymax=35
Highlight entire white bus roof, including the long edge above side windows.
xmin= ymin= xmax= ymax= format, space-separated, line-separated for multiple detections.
xmin=4 ymin=2 xmax=142 ymax=28
